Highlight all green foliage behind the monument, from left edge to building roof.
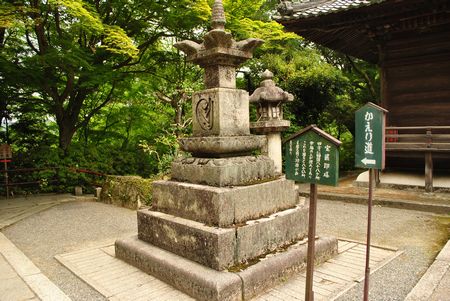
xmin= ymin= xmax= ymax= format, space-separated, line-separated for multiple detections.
xmin=0 ymin=0 xmax=379 ymax=196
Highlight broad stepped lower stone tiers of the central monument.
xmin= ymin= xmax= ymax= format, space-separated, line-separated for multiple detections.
xmin=115 ymin=170 xmax=337 ymax=301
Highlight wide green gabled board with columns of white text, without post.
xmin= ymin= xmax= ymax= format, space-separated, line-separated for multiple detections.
xmin=285 ymin=125 xmax=341 ymax=186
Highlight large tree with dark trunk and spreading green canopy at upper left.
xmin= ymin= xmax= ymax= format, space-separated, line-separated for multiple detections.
xmin=0 ymin=0 xmax=210 ymax=154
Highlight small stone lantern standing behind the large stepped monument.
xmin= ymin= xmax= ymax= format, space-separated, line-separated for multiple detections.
xmin=250 ymin=70 xmax=294 ymax=173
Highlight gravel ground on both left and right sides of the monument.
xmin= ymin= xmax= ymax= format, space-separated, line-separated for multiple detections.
xmin=3 ymin=200 xmax=450 ymax=301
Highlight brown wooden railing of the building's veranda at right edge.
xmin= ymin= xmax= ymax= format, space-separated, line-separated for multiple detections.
xmin=386 ymin=126 xmax=450 ymax=192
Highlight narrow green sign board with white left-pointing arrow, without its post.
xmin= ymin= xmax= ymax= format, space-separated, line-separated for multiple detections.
xmin=355 ymin=102 xmax=387 ymax=169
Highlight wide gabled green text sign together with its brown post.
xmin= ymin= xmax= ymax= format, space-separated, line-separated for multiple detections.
xmin=285 ymin=125 xmax=341 ymax=301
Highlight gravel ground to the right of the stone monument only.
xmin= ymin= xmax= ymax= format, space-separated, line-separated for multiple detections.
xmin=317 ymin=200 xmax=450 ymax=301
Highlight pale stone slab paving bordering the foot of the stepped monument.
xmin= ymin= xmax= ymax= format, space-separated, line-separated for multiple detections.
xmin=55 ymin=240 xmax=401 ymax=301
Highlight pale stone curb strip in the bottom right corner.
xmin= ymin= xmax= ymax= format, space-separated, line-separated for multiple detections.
xmin=405 ymin=240 xmax=450 ymax=301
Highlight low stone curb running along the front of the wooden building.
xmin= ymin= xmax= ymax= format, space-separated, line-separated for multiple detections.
xmin=299 ymin=191 xmax=450 ymax=214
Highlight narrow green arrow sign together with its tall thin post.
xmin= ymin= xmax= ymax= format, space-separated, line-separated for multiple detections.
xmin=355 ymin=102 xmax=388 ymax=301
